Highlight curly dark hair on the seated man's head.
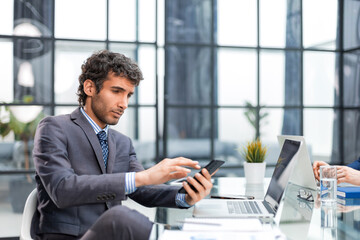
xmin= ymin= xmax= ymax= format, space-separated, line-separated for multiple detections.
xmin=77 ymin=50 xmax=143 ymax=106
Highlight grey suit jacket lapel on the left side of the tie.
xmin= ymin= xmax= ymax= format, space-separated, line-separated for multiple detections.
xmin=70 ymin=108 xmax=107 ymax=173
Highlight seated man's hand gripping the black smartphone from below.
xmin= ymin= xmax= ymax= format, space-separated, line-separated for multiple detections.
xmin=183 ymin=168 xmax=213 ymax=205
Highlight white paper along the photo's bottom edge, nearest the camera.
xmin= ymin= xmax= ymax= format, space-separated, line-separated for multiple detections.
xmin=159 ymin=230 xmax=286 ymax=240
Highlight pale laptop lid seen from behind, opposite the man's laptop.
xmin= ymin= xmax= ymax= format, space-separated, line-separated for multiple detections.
xmin=277 ymin=135 xmax=317 ymax=191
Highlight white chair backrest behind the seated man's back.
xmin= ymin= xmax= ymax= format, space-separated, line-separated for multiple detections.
xmin=20 ymin=188 xmax=37 ymax=240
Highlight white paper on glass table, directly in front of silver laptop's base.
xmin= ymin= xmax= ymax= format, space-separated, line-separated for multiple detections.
xmin=182 ymin=218 xmax=263 ymax=232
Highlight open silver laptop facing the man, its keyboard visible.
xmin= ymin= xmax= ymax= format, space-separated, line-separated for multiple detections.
xmin=193 ymin=139 xmax=301 ymax=218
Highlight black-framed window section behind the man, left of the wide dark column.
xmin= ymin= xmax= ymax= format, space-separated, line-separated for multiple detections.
xmin=0 ymin=0 xmax=158 ymax=237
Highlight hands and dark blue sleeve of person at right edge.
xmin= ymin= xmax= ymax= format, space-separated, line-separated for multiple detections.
xmin=313 ymin=158 xmax=360 ymax=185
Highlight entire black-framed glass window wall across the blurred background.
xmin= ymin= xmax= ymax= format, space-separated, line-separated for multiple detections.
xmin=0 ymin=0 xmax=360 ymax=237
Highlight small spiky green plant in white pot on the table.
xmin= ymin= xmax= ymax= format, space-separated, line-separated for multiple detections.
xmin=241 ymin=138 xmax=267 ymax=184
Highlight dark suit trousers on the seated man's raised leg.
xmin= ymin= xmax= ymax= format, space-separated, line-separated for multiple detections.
xmin=35 ymin=205 xmax=153 ymax=240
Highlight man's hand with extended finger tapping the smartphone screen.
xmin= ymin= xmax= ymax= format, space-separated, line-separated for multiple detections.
xmin=135 ymin=157 xmax=200 ymax=187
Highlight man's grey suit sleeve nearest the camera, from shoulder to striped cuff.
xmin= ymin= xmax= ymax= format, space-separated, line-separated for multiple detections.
xmin=33 ymin=117 xmax=130 ymax=208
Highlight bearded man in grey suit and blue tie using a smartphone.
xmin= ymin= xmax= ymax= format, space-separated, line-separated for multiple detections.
xmin=32 ymin=50 xmax=212 ymax=240
